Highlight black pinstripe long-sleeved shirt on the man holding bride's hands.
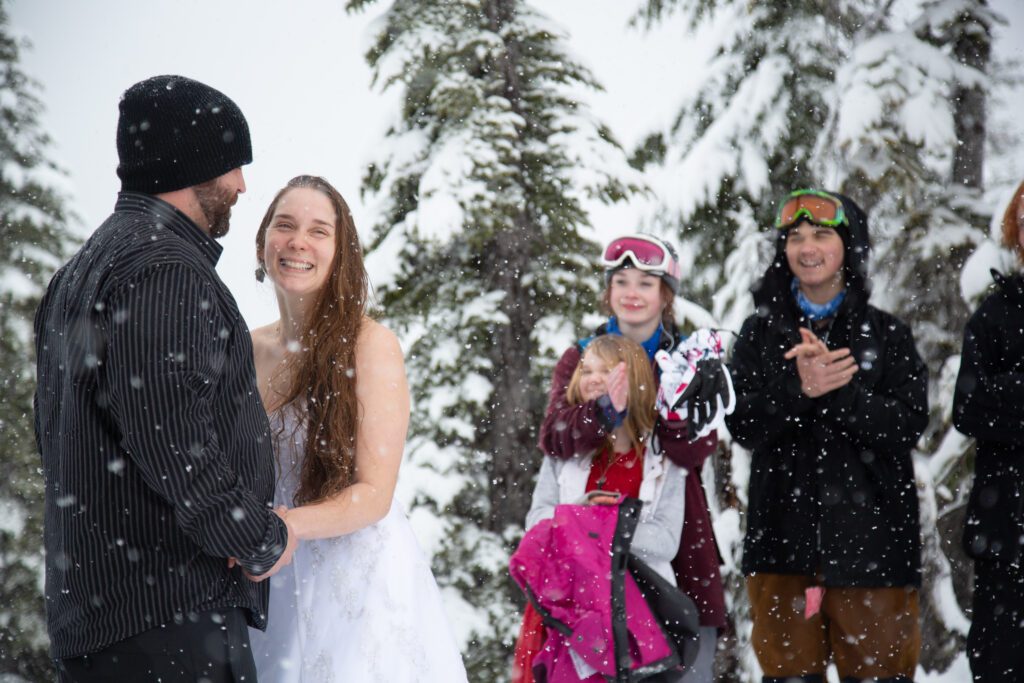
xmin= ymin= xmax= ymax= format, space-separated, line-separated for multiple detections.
xmin=35 ymin=193 xmax=286 ymax=657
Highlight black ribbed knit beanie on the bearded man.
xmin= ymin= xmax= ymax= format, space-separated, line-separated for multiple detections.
xmin=118 ymin=76 xmax=253 ymax=195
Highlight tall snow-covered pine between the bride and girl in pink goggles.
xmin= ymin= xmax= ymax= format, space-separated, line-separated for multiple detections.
xmin=347 ymin=0 xmax=638 ymax=681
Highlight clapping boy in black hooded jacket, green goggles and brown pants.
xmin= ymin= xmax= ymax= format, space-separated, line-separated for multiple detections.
xmin=726 ymin=190 xmax=928 ymax=681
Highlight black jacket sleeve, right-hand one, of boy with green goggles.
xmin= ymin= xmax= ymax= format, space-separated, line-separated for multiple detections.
xmin=817 ymin=318 xmax=928 ymax=453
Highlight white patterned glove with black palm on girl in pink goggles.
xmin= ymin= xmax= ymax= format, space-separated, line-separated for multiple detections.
xmin=654 ymin=329 xmax=736 ymax=440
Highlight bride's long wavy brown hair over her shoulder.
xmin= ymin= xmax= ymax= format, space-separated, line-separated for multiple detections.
xmin=256 ymin=175 xmax=369 ymax=505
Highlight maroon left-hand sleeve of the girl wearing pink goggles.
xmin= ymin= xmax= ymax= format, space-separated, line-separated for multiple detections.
xmin=538 ymin=345 xmax=618 ymax=458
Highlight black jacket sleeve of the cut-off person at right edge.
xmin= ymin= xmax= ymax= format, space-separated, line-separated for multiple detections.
xmin=953 ymin=304 xmax=1024 ymax=445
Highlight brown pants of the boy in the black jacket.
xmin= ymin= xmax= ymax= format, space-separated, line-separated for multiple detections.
xmin=746 ymin=573 xmax=921 ymax=679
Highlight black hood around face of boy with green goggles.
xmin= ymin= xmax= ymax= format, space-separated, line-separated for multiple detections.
xmin=751 ymin=191 xmax=871 ymax=310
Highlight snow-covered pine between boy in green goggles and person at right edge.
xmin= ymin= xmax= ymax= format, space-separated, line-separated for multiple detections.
xmin=825 ymin=0 xmax=998 ymax=671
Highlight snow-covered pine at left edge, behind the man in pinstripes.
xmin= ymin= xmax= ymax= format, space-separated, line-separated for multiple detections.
xmin=0 ymin=0 xmax=71 ymax=681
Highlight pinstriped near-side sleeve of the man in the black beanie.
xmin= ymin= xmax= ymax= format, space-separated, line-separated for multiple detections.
xmin=100 ymin=263 xmax=287 ymax=573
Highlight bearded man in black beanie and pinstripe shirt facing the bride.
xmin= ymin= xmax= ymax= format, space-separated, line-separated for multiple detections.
xmin=35 ymin=76 xmax=296 ymax=681
